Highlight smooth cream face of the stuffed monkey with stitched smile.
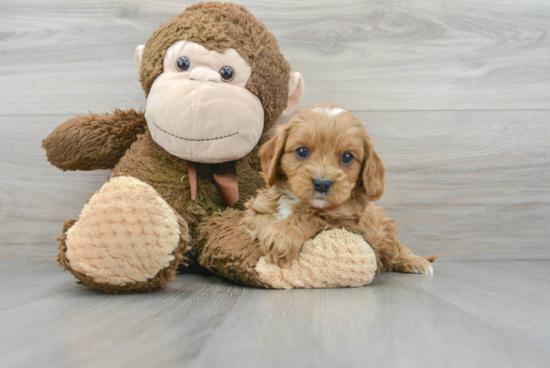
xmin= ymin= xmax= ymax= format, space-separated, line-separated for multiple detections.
xmin=142 ymin=41 xmax=264 ymax=163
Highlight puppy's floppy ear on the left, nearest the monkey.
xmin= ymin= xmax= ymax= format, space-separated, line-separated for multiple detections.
xmin=260 ymin=121 xmax=293 ymax=187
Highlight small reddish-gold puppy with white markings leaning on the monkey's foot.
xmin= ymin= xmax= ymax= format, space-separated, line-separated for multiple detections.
xmin=243 ymin=105 xmax=436 ymax=274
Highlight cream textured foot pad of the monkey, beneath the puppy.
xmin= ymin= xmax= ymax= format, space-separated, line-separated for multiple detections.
xmin=256 ymin=230 xmax=376 ymax=289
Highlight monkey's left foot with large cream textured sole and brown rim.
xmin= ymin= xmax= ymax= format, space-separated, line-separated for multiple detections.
xmin=57 ymin=176 xmax=189 ymax=293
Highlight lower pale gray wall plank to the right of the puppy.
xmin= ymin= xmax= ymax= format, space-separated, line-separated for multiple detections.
xmin=362 ymin=111 xmax=550 ymax=259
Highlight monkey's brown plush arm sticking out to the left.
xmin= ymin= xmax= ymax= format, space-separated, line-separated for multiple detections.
xmin=42 ymin=109 xmax=147 ymax=171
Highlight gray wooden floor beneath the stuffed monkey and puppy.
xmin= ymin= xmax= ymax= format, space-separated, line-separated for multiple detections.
xmin=0 ymin=261 xmax=550 ymax=368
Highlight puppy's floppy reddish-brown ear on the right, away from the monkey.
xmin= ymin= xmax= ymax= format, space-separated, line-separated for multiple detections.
xmin=361 ymin=133 xmax=386 ymax=201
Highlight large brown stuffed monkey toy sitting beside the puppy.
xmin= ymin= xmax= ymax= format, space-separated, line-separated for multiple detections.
xmin=42 ymin=2 xmax=376 ymax=293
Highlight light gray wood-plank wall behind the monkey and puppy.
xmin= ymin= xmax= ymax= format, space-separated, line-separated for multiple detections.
xmin=0 ymin=0 xmax=550 ymax=260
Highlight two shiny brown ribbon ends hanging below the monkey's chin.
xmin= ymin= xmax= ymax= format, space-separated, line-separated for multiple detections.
xmin=187 ymin=161 xmax=239 ymax=207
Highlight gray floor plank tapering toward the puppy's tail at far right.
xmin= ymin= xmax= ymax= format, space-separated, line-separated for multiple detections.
xmin=395 ymin=261 xmax=550 ymax=351
